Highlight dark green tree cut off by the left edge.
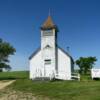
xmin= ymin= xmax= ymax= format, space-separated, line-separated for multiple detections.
xmin=0 ymin=39 xmax=16 ymax=71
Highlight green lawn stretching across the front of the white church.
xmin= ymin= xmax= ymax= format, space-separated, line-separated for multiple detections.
xmin=0 ymin=72 xmax=100 ymax=100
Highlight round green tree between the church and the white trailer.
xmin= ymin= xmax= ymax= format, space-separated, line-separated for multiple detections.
xmin=76 ymin=57 xmax=97 ymax=74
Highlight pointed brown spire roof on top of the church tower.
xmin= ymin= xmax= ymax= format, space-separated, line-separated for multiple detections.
xmin=41 ymin=15 xmax=57 ymax=30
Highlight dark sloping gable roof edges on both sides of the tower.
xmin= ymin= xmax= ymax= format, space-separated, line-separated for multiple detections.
xmin=29 ymin=45 xmax=74 ymax=63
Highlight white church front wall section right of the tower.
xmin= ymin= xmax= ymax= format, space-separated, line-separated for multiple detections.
xmin=58 ymin=48 xmax=71 ymax=80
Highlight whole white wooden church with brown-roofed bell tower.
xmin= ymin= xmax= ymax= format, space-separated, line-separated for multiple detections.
xmin=29 ymin=16 xmax=74 ymax=80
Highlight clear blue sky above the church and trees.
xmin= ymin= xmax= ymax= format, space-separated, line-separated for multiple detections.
xmin=0 ymin=0 xmax=100 ymax=70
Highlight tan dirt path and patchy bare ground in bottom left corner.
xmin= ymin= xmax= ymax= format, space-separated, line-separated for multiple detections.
xmin=0 ymin=80 xmax=50 ymax=100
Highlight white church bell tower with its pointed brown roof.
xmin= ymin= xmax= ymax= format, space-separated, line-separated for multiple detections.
xmin=41 ymin=15 xmax=58 ymax=77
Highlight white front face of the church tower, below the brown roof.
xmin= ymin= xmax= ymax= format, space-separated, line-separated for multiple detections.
xmin=41 ymin=29 xmax=56 ymax=77
